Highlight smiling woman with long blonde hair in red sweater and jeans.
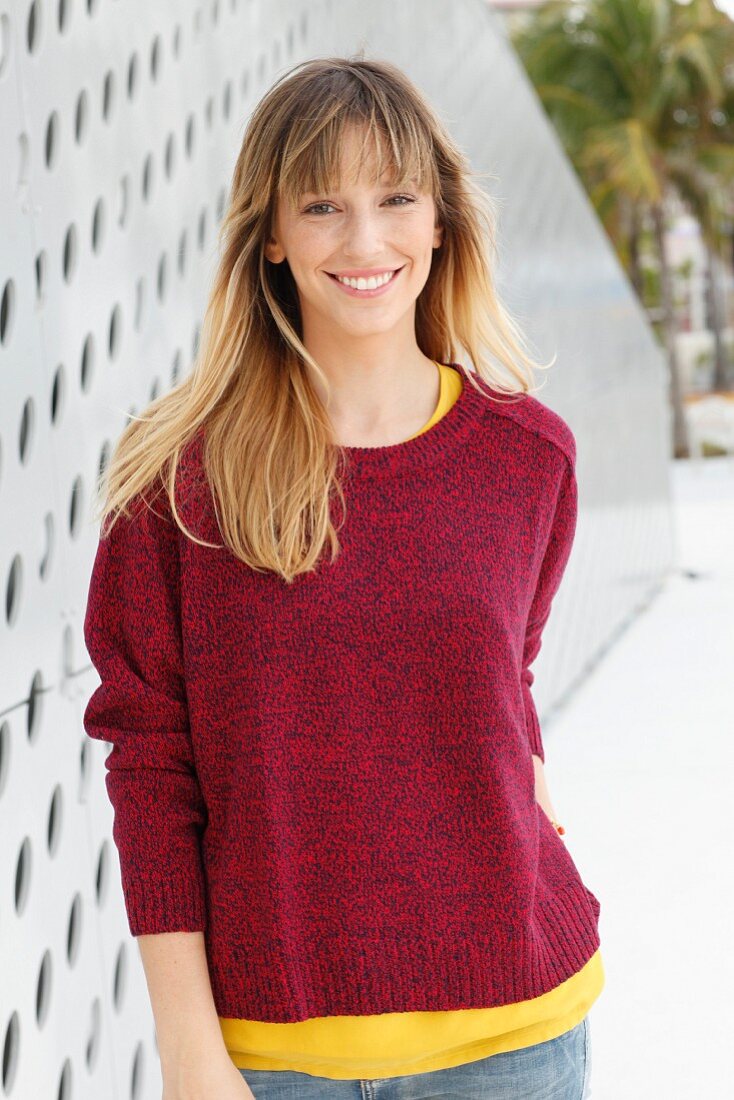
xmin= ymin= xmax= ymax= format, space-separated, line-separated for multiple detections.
xmin=85 ymin=58 xmax=603 ymax=1100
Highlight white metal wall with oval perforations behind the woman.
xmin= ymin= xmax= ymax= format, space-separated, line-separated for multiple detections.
xmin=0 ymin=0 xmax=671 ymax=1100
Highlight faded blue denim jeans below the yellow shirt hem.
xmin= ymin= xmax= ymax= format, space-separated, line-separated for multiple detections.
xmin=240 ymin=1016 xmax=591 ymax=1100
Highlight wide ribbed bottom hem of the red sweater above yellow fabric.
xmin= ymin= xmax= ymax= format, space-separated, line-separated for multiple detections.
xmin=209 ymin=880 xmax=600 ymax=1023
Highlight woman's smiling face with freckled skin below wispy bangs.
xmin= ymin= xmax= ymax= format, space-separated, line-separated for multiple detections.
xmin=265 ymin=125 xmax=442 ymax=344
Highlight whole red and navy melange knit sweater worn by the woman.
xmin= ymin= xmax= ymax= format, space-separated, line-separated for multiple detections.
xmin=84 ymin=364 xmax=600 ymax=1022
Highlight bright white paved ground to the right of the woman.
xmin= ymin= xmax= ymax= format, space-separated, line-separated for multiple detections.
xmin=545 ymin=457 xmax=734 ymax=1100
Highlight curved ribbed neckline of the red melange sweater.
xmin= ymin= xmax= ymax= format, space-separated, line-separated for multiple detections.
xmin=339 ymin=361 xmax=486 ymax=477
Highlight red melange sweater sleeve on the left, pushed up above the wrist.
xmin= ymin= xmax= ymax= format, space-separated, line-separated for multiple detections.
xmin=83 ymin=494 xmax=207 ymax=936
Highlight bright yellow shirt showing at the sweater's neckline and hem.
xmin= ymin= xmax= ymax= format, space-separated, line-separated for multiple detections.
xmin=219 ymin=363 xmax=604 ymax=1080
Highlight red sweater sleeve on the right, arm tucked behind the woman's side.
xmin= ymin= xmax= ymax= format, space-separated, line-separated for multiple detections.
xmin=521 ymin=458 xmax=578 ymax=762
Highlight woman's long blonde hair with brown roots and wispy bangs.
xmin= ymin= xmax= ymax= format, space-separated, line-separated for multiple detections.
xmin=90 ymin=56 xmax=552 ymax=582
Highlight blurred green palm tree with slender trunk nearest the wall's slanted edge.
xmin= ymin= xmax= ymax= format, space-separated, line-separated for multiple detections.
xmin=512 ymin=0 xmax=734 ymax=458
